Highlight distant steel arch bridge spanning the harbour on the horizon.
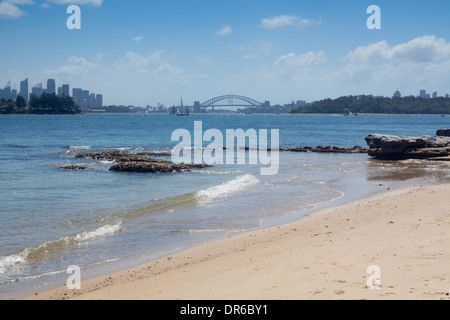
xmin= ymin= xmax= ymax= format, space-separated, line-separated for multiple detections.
xmin=189 ymin=94 xmax=270 ymax=112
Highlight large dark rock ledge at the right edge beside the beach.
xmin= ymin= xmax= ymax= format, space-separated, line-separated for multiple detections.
xmin=366 ymin=129 xmax=450 ymax=159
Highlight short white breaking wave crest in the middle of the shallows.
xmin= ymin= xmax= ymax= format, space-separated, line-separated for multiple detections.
xmin=196 ymin=174 xmax=260 ymax=201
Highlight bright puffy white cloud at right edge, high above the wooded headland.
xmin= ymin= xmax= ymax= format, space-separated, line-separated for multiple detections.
xmin=346 ymin=36 xmax=450 ymax=64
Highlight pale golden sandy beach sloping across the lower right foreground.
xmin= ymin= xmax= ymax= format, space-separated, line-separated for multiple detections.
xmin=25 ymin=185 xmax=450 ymax=300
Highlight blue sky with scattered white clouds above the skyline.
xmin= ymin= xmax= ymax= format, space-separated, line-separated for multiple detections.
xmin=0 ymin=0 xmax=450 ymax=106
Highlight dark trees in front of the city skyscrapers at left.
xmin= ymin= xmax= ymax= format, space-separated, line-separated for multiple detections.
xmin=0 ymin=93 xmax=82 ymax=114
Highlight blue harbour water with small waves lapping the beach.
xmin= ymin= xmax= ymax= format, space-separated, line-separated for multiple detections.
xmin=0 ymin=114 xmax=450 ymax=299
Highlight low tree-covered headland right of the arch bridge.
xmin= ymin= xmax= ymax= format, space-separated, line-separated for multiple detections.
xmin=291 ymin=95 xmax=450 ymax=114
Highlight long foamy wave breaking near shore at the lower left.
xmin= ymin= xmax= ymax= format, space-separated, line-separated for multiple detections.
xmin=0 ymin=222 xmax=122 ymax=274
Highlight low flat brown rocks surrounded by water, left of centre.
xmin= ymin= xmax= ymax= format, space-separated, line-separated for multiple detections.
xmin=75 ymin=151 xmax=210 ymax=173
